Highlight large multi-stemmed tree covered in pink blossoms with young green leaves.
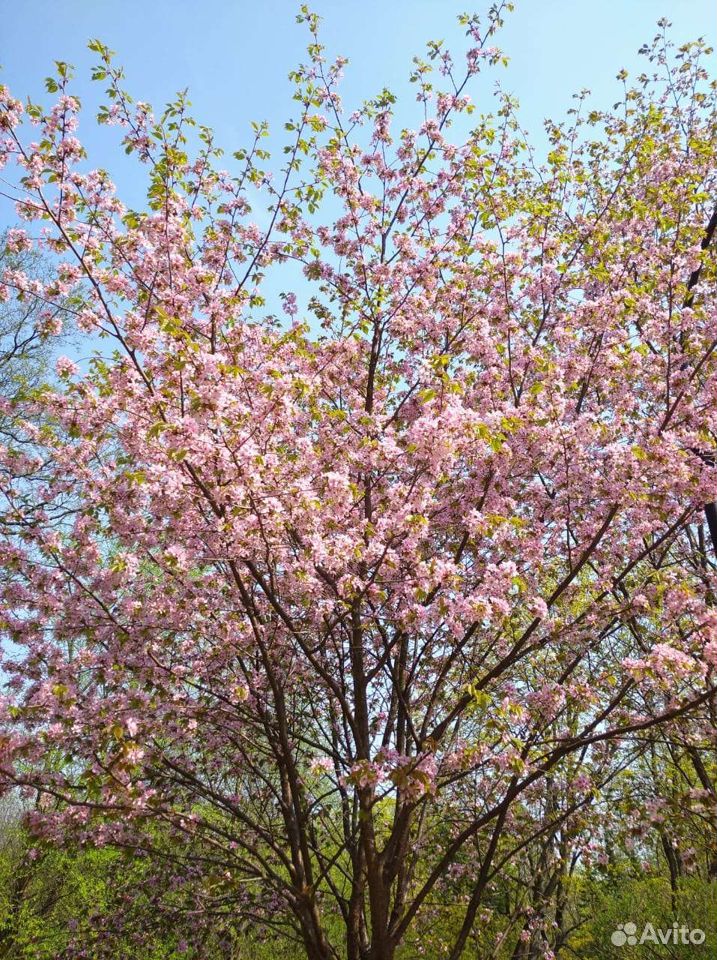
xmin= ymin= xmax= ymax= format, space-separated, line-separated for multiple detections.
xmin=0 ymin=4 xmax=717 ymax=960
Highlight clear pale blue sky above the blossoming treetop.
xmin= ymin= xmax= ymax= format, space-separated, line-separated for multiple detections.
xmin=0 ymin=0 xmax=717 ymax=205
